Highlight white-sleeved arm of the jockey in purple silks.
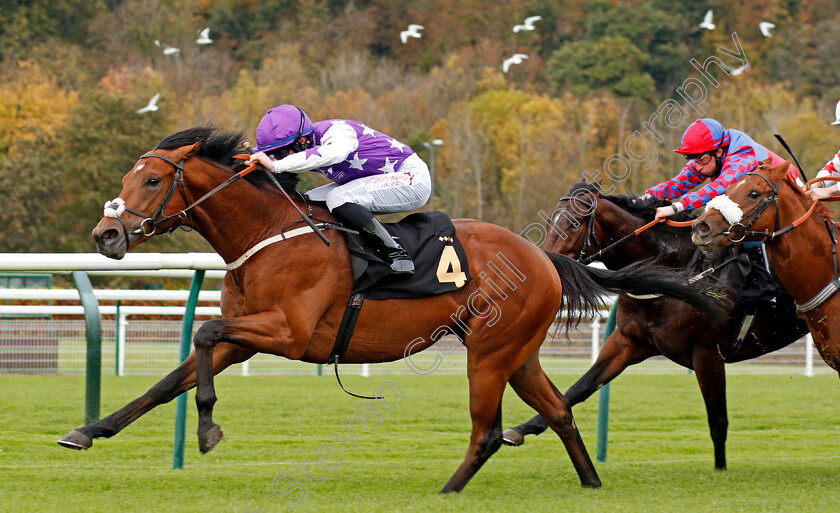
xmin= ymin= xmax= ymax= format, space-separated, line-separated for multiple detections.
xmin=274 ymin=121 xmax=359 ymax=173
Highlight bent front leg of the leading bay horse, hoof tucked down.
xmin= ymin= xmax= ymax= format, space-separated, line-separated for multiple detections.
xmin=193 ymin=310 xmax=309 ymax=454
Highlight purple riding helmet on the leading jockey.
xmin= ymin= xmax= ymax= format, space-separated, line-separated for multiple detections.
xmin=256 ymin=103 xmax=315 ymax=159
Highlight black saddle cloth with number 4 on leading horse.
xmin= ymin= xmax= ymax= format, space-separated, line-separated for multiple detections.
xmin=343 ymin=212 xmax=472 ymax=299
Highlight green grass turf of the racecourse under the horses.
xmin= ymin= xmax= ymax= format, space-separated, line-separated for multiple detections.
xmin=0 ymin=374 xmax=840 ymax=513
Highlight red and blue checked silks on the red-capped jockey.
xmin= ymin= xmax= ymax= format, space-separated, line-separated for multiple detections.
xmin=645 ymin=129 xmax=769 ymax=210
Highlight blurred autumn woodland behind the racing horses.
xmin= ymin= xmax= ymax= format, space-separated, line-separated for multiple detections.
xmin=0 ymin=0 xmax=840 ymax=252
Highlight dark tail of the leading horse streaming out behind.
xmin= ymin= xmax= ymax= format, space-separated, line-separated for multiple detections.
xmin=545 ymin=251 xmax=728 ymax=328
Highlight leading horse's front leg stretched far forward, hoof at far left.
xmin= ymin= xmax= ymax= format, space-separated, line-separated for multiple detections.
xmin=58 ymin=344 xmax=254 ymax=449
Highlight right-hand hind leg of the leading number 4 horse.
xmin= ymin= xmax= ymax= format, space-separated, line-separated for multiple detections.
xmin=509 ymin=352 xmax=601 ymax=488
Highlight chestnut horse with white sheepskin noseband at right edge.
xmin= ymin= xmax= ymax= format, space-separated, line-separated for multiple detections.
xmin=692 ymin=160 xmax=840 ymax=373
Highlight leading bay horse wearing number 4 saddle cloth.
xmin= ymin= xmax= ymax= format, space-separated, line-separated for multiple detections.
xmin=59 ymin=127 xmax=714 ymax=492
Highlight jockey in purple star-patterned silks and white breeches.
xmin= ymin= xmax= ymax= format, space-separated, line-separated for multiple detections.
xmin=250 ymin=104 xmax=431 ymax=274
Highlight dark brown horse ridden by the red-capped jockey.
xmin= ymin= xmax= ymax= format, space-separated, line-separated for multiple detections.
xmin=503 ymin=182 xmax=805 ymax=469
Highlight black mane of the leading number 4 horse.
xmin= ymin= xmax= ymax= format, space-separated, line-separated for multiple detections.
xmin=155 ymin=125 xmax=300 ymax=193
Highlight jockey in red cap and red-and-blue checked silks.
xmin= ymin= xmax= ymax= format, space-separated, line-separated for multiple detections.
xmin=645 ymin=118 xmax=799 ymax=219
